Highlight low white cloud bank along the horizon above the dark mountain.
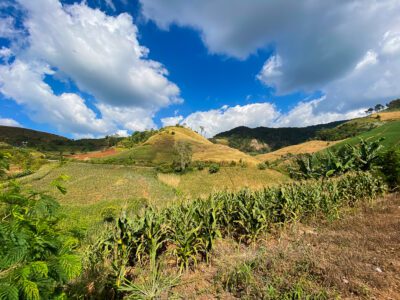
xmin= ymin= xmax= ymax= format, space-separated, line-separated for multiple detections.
xmin=166 ymin=99 xmax=364 ymax=137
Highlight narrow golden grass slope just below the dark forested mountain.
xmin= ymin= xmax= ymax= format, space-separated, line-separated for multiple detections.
xmin=256 ymin=141 xmax=341 ymax=161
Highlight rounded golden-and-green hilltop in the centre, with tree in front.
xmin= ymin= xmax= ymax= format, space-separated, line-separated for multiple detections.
xmin=104 ymin=127 xmax=257 ymax=164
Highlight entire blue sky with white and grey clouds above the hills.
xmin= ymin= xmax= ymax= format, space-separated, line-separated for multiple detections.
xmin=0 ymin=0 xmax=400 ymax=138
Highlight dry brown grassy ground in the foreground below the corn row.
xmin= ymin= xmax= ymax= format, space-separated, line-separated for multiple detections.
xmin=173 ymin=194 xmax=400 ymax=300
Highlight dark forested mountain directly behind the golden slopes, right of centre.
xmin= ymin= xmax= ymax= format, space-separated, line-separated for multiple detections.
xmin=212 ymin=121 xmax=346 ymax=153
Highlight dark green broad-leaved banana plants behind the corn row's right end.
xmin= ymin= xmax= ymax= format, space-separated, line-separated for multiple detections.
xmin=289 ymin=139 xmax=383 ymax=179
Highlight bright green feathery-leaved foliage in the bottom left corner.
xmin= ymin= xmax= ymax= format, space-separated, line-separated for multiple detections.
xmin=0 ymin=183 xmax=81 ymax=299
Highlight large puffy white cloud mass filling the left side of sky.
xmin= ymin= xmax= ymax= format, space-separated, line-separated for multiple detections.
xmin=0 ymin=0 xmax=182 ymax=134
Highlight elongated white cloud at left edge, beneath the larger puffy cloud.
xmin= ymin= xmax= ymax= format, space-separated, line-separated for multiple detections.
xmin=0 ymin=59 xmax=112 ymax=134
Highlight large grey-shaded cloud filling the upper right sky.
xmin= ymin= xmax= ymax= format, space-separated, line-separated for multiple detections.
xmin=140 ymin=0 xmax=400 ymax=113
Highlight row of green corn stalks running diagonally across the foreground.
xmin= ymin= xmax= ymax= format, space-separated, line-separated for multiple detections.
xmin=90 ymin=172 xmax=386 ymax=293
